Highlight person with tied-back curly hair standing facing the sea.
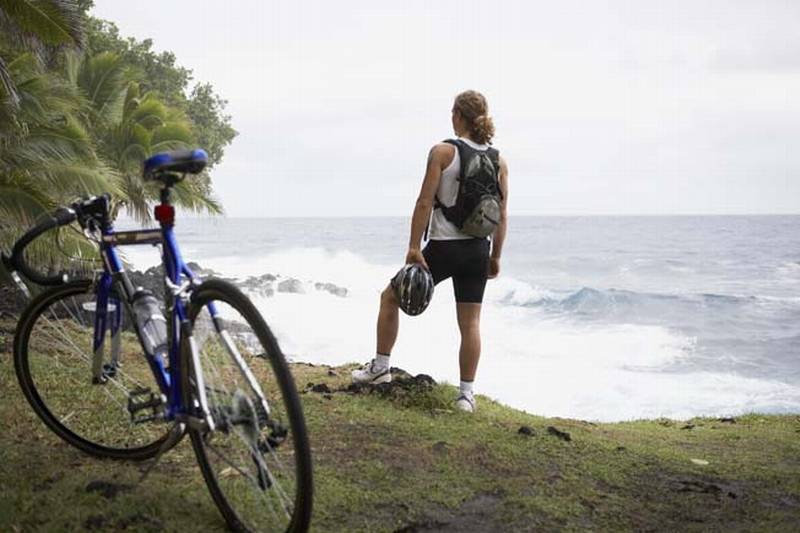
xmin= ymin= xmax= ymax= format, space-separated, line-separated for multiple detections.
xmin=352 ymin=91 xmax=508 ymax=412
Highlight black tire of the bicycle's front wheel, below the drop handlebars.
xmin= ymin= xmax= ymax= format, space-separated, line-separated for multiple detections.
xmin=14 ymin=280 xmax=180 ymax=461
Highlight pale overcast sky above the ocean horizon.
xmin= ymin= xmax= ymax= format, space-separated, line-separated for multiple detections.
xmin=94 ymin=0 xmax=800 ymax=216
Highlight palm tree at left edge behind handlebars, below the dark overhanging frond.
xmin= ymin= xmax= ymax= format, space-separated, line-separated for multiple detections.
xmin=0 ymin=53 xmax=116 ymax=274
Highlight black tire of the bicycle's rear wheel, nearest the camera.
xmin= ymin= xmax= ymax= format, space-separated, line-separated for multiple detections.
xmin=181 ymin=279 xmax=313 ymax=533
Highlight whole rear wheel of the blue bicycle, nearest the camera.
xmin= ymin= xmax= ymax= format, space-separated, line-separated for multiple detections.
xmin=182 ymin=280 xmax=312 ymax=532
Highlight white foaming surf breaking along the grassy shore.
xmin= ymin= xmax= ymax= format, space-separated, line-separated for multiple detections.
xmin=126 ymin=248 xmax=800 ymax=421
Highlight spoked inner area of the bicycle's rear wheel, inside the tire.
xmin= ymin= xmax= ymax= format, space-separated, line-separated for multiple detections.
xmin=193 ymin=302 xmax=297 ymax=526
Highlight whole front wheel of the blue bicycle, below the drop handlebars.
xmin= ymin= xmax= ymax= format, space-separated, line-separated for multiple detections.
xmin=14 ymin=281 xmax=174 ymax=460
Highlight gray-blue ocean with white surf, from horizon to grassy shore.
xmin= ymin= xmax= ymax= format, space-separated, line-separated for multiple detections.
xmin=121 ymin=216 xmax=800 ymax=421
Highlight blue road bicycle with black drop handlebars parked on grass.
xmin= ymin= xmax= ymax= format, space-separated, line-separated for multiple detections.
xmin=2 ymin=150 xmax=312 ymax=531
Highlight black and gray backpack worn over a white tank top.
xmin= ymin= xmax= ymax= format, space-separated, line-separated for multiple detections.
xmin=434 ymin=139 xmax=503 ymax=237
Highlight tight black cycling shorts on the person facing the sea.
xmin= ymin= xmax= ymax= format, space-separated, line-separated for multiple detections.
xmin=422 ymin=239 xmax=489 ymax=303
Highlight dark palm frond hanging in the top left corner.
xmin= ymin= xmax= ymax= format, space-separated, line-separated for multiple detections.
xmin=0 ymin=0 xmax=85 ymax=105
